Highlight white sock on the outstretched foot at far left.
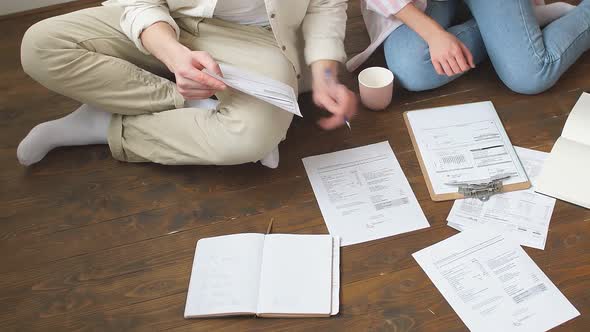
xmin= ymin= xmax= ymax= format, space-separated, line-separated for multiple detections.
xmin=16 ymin=104 xmax=111 ymax=166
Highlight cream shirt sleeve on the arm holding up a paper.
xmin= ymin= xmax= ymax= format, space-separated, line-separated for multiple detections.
xmin=117 ymin=0 xmax=180 ymax=54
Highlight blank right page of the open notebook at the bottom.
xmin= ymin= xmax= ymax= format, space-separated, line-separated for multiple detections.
xmin=258 ymin=234 xmax=333 ymax=316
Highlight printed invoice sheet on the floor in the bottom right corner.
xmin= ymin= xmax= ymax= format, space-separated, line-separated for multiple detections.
xmin=413 ymin=226 xmax=580 ymax=332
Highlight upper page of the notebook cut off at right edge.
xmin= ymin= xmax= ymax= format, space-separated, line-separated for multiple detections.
xmin=561 ymin=92 xmax=590 ymax=146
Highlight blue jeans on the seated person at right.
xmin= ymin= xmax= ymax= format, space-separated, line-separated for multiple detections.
xmin=385 ymin=0 xmax=590 ymax=94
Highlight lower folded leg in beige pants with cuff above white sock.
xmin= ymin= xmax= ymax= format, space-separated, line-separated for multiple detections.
xmin=117 ymin=91 xmax=293 ymax=165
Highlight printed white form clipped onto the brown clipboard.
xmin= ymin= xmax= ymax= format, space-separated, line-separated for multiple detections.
xmin=404 ymin=101 xmax=531 ymax=201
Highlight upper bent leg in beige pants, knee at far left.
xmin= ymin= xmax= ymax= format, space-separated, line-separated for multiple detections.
xmin=21 ymin=7 xmax=178 ymax=115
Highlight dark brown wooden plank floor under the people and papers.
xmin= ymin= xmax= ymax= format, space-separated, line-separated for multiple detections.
xmin=0 ymin=1 xmax=590 ymax=331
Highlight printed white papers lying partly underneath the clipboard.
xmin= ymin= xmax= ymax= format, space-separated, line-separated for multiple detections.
xmin=447 ymin=147 xmax=555 ymax=250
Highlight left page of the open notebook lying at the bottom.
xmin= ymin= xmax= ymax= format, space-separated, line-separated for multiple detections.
xmin=184 ymin=234 xmax=264 ymax=318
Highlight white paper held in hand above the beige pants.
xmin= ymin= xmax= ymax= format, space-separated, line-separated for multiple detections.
xmin=204 ymin=63 xmax=302 ymax=116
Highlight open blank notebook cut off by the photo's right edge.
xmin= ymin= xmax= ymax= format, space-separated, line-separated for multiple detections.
xmin=535 ymin=93 xmax=590 ymax=209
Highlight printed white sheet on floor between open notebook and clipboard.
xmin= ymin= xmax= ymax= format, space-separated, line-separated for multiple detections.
xmin=303 ymin=142 xmax=430 ymax=246
